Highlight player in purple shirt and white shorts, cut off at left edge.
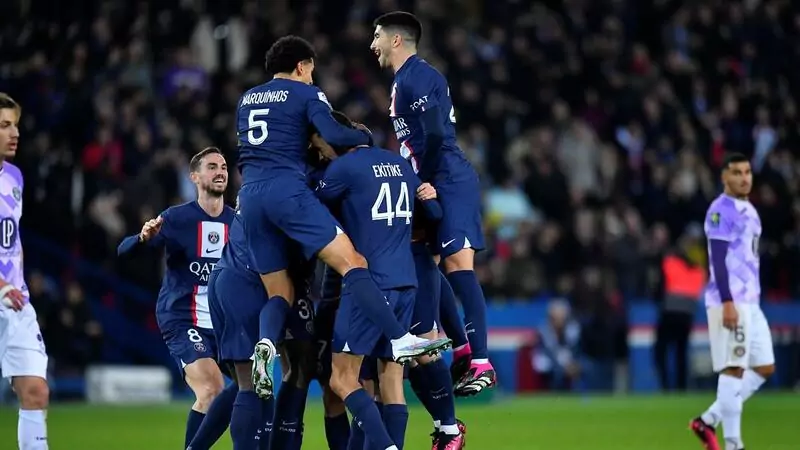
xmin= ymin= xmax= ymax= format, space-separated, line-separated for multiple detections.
xmin=0 ymin=92 xmax=50 ymax=450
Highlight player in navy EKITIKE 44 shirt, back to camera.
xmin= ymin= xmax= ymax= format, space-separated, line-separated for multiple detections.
xmin=317 ymin=109 xmax=449 ymax=450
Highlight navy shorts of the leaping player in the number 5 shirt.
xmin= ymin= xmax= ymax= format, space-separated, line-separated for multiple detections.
xmin=239 ymin=177 xmax=342 ymax=274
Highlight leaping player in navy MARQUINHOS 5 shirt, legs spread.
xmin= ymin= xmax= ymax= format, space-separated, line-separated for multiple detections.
xmin=236 ymin=36 xmax=454 ymax=409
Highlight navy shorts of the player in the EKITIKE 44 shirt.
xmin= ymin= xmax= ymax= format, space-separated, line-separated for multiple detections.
xmin=332 ymin=288 xmax=417 ymax=359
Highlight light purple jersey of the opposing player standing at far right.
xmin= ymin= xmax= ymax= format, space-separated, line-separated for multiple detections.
xmin=703 ymin=194 xmax=761 ymax=307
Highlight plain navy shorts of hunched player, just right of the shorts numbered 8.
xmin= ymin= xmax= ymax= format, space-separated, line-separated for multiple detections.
xmin=208 ymin=268 xmax=269 ymax=362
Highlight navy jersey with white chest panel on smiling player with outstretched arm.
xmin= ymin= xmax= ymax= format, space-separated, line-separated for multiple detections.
xmin=118 ymin=201 xmax=234 ymax=330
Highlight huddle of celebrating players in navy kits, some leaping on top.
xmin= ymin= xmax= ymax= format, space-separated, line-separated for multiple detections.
xmin=118 ymin=12 xmax=496 ymax=450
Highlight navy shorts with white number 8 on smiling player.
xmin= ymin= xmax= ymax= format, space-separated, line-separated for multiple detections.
xmin=161 ymin=321 xmax=217 ymax=373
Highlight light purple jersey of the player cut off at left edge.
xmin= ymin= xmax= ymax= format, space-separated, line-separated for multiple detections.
xmin=0 ymin=162 xmax=28 ymax=309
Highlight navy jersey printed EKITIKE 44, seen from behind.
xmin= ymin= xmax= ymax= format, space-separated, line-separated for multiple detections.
xmin=317 ymin=147 xmax=420 ymax=290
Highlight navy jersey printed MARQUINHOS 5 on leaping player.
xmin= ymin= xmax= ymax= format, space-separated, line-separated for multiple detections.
xmin=236 ymin=78 xmax=370 ymax=184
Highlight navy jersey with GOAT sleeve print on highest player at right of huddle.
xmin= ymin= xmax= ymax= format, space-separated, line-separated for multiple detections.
xmin=389 ymin=55 xmax=471 ymax=178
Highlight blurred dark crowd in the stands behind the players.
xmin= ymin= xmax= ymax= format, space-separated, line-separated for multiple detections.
xmin=0 ymin=0 xmax=800 ymax=380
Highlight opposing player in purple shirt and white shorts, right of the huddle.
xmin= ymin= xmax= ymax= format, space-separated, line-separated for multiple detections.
xmin=690 ymin=153 xmax=775 ymax=450
